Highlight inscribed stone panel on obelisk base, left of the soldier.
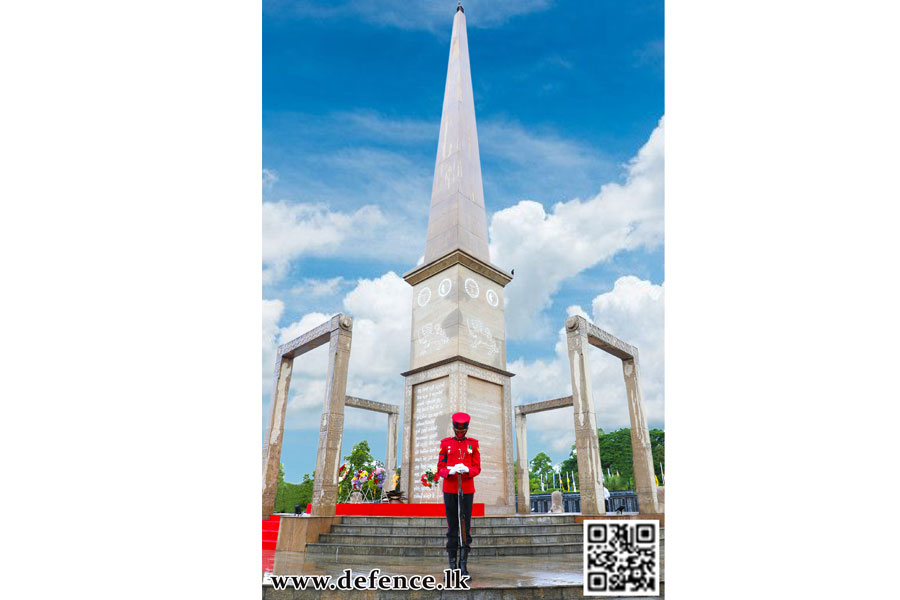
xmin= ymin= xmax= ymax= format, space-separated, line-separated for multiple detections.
xmin=410 ymin=377 xmax=451 ymax=502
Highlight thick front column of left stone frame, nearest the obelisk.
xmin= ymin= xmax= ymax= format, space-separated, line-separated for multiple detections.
xmin=312 ymin=316 xmax=353 ymax=517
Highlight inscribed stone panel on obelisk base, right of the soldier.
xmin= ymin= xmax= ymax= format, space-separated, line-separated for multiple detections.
xmin=466 ymin=376 xmax=507 ymax=504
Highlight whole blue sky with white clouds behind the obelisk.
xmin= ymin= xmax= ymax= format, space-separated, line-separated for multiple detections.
xmin=261 ymin=0 xmax=664 ymax=481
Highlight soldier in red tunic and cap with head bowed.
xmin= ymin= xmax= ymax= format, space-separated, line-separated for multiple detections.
xmin=437 ymin=413 xmax=481 ymax=575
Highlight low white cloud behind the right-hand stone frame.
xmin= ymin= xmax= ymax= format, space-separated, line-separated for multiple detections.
xmin=509 ymin=275 xmax=665 ymax=454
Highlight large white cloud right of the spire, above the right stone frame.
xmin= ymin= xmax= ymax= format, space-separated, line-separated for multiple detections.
xmin=490 ymin=119 xmax=665 ymax=338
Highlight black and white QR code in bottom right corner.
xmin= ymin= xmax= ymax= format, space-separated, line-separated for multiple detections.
xmin=584 ymin=520 xmax=659 ymax=596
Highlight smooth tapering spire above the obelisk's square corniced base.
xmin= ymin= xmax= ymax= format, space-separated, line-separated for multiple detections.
xmin=425 ymin=1 xmax=490 ymax=264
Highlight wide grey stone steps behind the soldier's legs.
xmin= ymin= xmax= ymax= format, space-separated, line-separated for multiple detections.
xmin=306 ymin=515 xmax=583 ymax=558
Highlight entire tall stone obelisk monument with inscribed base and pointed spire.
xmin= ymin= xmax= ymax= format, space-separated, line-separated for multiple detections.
xmin=401 ymin=6 xmax=515 ymax=514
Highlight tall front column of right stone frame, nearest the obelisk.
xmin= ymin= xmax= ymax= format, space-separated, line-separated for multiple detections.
xmin=566 ymin=317 xmax=606 ymax=515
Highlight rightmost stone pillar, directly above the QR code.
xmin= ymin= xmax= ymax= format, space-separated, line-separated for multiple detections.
xmin=622 ymin=354 xmax=659 ymax=514
